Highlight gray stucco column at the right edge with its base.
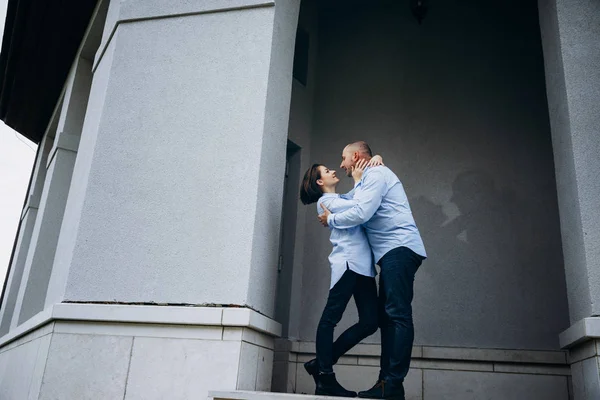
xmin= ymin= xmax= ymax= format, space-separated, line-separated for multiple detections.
xmin=538 ymin=0 xmax=600 ymax=399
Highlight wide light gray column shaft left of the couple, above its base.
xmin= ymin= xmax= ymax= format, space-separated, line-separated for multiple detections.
xmin=47 ymin=0 xmax=300 ymax=316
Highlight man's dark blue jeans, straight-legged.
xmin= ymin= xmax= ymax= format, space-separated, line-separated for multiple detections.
xmin=378 ymin=247 xmax=424 ymax=385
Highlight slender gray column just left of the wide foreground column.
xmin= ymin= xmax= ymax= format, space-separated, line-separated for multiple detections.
xmin=13 ymin=59 xmax=91 ymax=326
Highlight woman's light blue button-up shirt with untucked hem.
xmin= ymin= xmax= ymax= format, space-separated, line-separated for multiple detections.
xmin=317 ymin=193 xmax=376 ymax=289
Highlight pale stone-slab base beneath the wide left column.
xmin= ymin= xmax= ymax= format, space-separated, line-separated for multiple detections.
xmin=0 ymin=304 xmax=281 ymax=399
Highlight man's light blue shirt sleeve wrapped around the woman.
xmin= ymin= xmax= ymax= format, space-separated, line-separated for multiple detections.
xmin=327 ymin=169 xmax=386 ymax=229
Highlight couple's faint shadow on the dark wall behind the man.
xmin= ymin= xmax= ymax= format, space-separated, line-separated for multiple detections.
xmin=411 ymin=171 xmax=522 ymax=346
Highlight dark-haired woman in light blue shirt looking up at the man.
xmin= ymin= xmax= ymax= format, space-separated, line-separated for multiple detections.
xmin=300 ymin=156 xmax=383 ymax=397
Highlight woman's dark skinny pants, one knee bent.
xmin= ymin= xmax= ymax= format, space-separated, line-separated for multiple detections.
xmin=317 ymin=269 xmax=378 ymax=374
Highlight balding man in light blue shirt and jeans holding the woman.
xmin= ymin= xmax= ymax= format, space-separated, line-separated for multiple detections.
xmin=319 ymin=141 xmax=427 ymax=400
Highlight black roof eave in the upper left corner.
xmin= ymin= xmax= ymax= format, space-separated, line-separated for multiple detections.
xmin=0 ymin=0 xmax=96 ymax=143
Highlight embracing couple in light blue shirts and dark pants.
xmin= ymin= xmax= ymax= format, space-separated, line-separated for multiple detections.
xmin=300 ymin=142 xmax=427 ymax=400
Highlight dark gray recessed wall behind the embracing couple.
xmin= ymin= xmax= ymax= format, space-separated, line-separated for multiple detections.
xmin=300 ymin=1 xmax=568 ymax=349
